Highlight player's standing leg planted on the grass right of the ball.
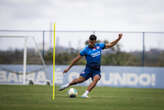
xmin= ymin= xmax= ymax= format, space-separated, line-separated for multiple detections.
xmin=81 ymin=75 xmax=101 ymax=98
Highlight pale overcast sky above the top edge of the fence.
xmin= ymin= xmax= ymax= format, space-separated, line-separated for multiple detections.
xmin=0 ymin=0 xmax=164 ymax=50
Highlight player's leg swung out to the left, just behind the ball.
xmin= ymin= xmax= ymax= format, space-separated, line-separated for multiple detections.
xmin=59 ymin=76 xmax=85 ymax=91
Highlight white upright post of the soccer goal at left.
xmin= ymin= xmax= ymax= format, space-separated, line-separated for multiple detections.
xmin=23 ymin=36 xmax=27 ymax=85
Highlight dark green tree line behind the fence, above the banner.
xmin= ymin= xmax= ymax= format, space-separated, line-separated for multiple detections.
xmin=0 ymin=41 xmax=164 ymax=67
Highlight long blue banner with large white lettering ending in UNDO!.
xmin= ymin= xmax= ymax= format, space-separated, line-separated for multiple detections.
xmin=0 ymin=65 xmax=164 ymax=88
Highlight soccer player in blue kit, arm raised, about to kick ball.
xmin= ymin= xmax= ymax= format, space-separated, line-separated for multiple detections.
xmin=59 ymin=33 xmax=123 ymax=98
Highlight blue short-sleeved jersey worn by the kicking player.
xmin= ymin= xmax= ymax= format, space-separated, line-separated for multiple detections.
xmin=80 ymin=43 xmax=105 ymax=65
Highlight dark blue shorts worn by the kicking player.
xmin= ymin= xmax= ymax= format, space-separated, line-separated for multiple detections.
xmin=80 ymin=67 xmax=101 ymax=80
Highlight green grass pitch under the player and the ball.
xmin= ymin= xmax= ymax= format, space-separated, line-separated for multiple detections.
xmin=0 ymin=85 xmax=164 ymax=110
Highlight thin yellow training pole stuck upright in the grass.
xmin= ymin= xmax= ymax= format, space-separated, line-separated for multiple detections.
xmin=52 ymin=24 xmax=55 ymax=100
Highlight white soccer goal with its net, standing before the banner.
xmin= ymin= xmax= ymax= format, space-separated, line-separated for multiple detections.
xmin=0 ymin=35 xmax=50 ymax=84
